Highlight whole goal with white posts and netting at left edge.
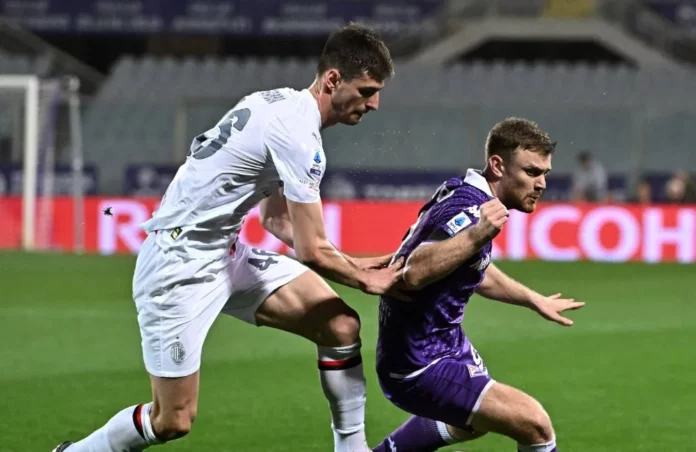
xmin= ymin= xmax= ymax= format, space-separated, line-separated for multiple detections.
xmin=0 ymin=75 xmax=83 ymax=251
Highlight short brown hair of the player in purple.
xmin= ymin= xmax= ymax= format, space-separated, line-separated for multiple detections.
xmin=486 ymin=118 xmax=556 ymax=160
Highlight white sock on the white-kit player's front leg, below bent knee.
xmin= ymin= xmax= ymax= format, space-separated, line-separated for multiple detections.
xmin=317 ymin=342 xmax=370 ymax=452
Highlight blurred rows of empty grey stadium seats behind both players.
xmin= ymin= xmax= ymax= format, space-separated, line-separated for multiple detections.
xmin=84 ymin=57 xmax=696 ymax=192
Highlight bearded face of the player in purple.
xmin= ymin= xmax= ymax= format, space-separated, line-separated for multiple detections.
xmin=499 ymin=149 xmax=551 ymax=213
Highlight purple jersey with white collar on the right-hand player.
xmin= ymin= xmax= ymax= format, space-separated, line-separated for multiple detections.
xmin=377 ymin=170 xmax=493 ymax=376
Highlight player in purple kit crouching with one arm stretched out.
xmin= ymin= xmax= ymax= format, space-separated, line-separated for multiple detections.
xmin=373 ymin=118 xmax=584 ymax=452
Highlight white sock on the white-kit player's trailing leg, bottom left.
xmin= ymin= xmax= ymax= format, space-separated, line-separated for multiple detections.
xmin=68 ymin=403 xmax=161 ymax=452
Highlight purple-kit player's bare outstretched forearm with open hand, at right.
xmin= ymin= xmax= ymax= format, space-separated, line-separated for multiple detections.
xmin=476 ymin=264 xmax=585 ymax=326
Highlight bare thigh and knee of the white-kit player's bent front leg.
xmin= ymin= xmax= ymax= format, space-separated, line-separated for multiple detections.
xmin=256 ymin=270 xmax=360 ymax=347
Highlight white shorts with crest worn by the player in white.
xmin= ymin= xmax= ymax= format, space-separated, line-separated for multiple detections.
xmin=133 ymin=234 xmax=307 ymax=378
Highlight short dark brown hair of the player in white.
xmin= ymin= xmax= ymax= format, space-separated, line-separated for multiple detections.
xmin=317 ymin=23 xmax=394 ymax=82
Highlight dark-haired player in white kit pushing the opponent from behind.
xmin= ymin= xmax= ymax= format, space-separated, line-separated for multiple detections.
xmin=54 ymin=25 xmax=402 ymax=452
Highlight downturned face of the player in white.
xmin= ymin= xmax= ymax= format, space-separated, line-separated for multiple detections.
xmin=331 ymin=75 xmax=384 ymax=126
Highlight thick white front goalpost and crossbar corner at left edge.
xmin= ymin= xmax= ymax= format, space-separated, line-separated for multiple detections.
xmin=0 ymin=75 xmax=40 ymax=250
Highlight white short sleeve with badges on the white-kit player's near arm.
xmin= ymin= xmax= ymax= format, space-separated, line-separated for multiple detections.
xmin=264 ymin=117 xmax=326 ymax=203
